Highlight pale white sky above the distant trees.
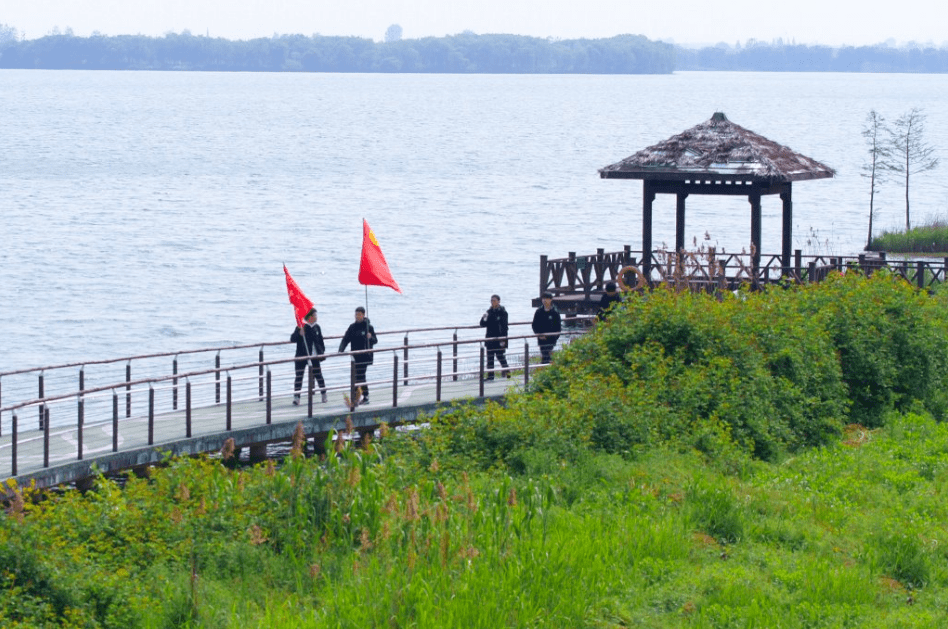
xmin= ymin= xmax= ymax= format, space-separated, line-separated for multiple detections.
xmin=0 ymin=0 xmax=948 ymax=46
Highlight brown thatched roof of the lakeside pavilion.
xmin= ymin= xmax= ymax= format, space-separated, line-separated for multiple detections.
xmin=599 ymin=112 xmax=835 ymax=182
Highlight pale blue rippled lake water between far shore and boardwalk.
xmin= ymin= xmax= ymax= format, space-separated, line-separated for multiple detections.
xmin=0 ymin=71 xmax=948 ymax=372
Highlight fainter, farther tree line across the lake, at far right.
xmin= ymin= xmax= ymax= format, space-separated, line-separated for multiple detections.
xmin=675 ymin=39 xmax=948 ymax=74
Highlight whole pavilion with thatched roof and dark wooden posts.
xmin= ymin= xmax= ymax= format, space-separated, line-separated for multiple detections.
xmin=599 ymin=112 xmax=835 ymax=277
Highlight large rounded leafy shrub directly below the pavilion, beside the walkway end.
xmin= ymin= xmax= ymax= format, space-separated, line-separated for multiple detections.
xmin=534 ymin=290 xmax=846 ymax=460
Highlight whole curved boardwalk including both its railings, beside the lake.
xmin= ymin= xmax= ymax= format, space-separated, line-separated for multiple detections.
xmin=0 ymin=322 xmax=582 ymax=487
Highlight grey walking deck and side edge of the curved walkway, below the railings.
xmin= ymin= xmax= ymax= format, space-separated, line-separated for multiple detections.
xmin=0 ymin=378 xmax=522 ymax=487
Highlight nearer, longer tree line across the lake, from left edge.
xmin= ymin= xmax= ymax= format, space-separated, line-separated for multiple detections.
xmin=0 ymin=25 xmax=675 ymax=74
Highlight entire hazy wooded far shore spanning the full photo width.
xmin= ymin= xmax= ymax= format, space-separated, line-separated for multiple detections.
xmin=0 ymin=30 xmax=948 ymax=74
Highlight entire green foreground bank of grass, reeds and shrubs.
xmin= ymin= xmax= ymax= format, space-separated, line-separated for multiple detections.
xmin=0 ymin=272 xmax=948 ymax=629
